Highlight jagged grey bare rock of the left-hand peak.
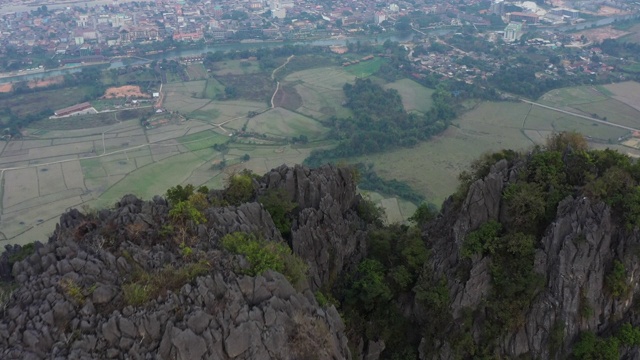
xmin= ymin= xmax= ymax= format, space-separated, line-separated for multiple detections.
xmin=0 ymin=167 xmax=362 ymax=359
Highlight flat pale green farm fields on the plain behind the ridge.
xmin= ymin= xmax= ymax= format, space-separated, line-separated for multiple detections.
xmin=5 ymin=59 xmax=640 ymax=248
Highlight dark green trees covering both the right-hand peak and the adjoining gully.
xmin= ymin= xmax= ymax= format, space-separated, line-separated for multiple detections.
xmin=330 ymin=133 xmax=640 ymax=359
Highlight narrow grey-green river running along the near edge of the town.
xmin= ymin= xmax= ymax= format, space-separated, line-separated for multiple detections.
xmin=0 ymin=30 xmax=416 ymax=84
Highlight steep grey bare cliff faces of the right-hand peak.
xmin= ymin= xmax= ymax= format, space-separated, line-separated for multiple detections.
xmin=423 ymin=160 xmax=640 ymax=359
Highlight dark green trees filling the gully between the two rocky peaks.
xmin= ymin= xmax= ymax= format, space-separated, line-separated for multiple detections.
xmin=333 ymin=225 xmax=431 ymax=359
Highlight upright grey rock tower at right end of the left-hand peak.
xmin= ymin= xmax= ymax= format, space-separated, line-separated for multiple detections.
xmin=263 ymin=165 xmax=366 ymax=289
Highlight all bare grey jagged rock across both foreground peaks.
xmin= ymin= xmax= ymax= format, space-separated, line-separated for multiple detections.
xmin=5 ymin=155 xmax=640 ymax=360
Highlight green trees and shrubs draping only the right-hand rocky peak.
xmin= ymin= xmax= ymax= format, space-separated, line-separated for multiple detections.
xmin=438 ymin=133 xmax=640 ymax=359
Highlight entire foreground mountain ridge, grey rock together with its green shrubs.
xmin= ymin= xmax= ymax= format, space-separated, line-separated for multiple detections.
xmin=0 ymin=141 xmax=640 ymax=360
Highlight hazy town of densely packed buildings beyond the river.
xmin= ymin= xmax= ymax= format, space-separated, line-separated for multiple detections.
xmin=0 ymin=0 xmax=640 ymax=75
